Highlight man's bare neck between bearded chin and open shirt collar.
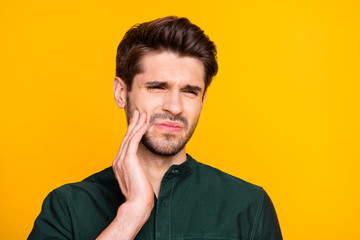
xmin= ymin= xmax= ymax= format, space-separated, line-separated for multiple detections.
xmin=138 ymin=143 xmax=186 ymax=196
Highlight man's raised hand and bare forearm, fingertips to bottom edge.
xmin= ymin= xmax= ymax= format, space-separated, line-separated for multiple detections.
xmin=97 ymin=110 xmax=154 ymax=240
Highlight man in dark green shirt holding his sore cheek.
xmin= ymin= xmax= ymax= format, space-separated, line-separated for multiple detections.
xmin=29 ymin=17 xmax=282 ymax=239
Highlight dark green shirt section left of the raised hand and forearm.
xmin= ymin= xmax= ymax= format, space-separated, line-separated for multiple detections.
xmin=29 ymin=168 xmax=124 ymax=239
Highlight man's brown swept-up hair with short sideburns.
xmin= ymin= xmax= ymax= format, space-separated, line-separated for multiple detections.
xmin=116 ymin=16 xmax=218 ymax=91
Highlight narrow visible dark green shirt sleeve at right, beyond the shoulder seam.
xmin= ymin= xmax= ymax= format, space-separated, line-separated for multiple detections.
xmin=250 ymin=190 xmax=283 ymax=240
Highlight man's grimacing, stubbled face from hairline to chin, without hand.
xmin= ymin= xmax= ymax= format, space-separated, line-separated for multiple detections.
xmin=126 ymin=52 xmax=205 ymax=156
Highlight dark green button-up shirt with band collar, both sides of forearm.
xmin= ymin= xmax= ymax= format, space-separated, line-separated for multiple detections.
xmin=28 ymin=155 xmax=282 ymax=240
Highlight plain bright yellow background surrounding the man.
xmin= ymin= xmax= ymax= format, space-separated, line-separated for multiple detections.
xmin=0 ymin=0 xmax=360 ymax=240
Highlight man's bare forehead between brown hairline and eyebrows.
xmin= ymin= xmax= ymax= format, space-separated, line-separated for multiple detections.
xmin=139 ymin=51 xmax=205 ymax=88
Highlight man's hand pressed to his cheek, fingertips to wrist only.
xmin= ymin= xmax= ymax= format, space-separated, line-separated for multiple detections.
xmin=113 ymin=110 xmax=154 ymax=208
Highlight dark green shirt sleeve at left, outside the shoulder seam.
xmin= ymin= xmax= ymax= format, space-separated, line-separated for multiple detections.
xmin=28 ymin=191 xmax=72 ymax=240
